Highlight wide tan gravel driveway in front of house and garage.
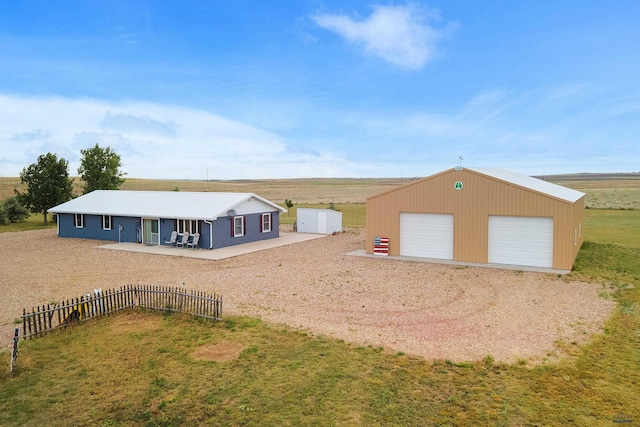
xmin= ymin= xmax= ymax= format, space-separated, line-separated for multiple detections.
xmin=0 ymin=230 xmax=615 ymax=363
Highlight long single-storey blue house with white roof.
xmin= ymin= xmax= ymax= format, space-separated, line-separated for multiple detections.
xmin=49 ymin=190 xmax=286 ymax=249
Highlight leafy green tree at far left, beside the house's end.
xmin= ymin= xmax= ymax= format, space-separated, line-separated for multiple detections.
xmin=13 ymin=153 xmax=73 ymax=225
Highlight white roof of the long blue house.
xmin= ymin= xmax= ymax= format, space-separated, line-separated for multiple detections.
xmin=49 ymin=190 xmax=287 ymax=220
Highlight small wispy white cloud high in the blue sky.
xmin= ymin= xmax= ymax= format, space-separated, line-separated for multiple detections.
xmin=312 ymin=4 xmax=455 ymax=70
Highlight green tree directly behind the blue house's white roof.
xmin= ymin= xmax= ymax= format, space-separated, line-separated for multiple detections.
xmin=78 ymin=144 xmax=126 ymax=194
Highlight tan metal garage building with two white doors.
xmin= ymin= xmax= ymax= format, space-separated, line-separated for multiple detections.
xmin=366 ymin=167 xmax=584 ymax=270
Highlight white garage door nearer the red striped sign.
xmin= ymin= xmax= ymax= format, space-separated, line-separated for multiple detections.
xmin=400 ymin=213 xmax=453 ymax=259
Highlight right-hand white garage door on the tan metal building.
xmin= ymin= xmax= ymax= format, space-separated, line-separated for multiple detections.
xmin=489 ymin=216 xmax=553 ymax=268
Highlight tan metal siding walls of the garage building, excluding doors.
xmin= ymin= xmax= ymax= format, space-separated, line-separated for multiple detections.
xmin=366 ymin=169 xmax=584 ymax=269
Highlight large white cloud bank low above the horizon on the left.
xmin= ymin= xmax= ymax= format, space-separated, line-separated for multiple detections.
xmin=0 ymin=95 xmax=380 ymax=179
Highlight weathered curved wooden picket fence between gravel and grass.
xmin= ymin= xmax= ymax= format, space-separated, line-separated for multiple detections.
xmin=22 ymin=285 xmax=222 ymax=339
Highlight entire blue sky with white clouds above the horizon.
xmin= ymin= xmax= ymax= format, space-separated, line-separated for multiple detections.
xmin=0 ymin=0 xmax=640 ymax=179
